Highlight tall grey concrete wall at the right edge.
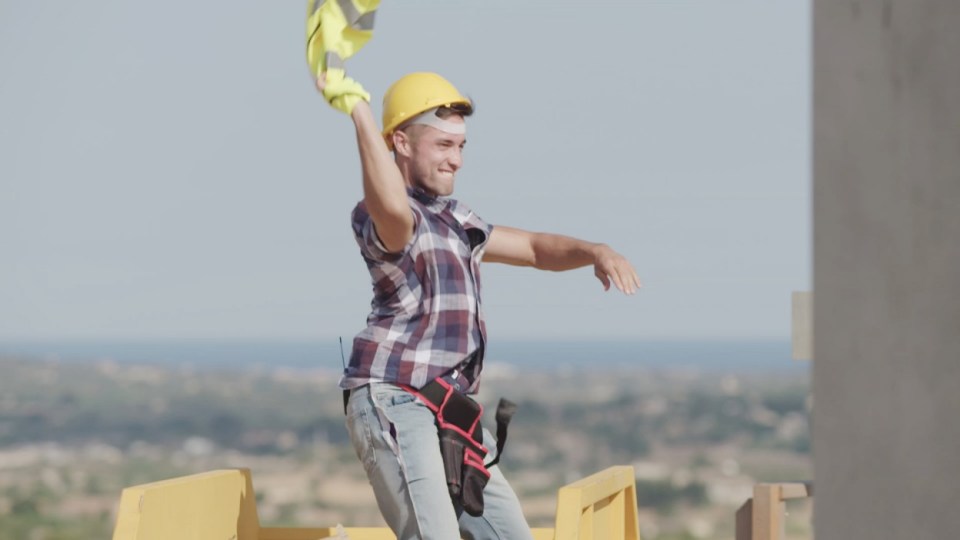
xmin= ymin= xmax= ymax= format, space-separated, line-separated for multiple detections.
xmin=813 ymin=0 xmax=960 ymax=540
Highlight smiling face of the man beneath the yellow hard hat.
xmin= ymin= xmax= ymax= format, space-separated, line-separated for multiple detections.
xmin=410 ymin=115 xmax=467 ymax=197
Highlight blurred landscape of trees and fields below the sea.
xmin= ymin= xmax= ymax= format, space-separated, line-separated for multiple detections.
xmin=0 ymin=346 xmax=812 ymax=540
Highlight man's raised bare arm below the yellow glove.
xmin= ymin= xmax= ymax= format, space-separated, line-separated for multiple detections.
xmin=317 ymin=77 xmax=413 ymax=252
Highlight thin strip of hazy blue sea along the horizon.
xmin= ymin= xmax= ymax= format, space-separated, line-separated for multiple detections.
xmin=0 ymin=338 xmax=810 ymax=373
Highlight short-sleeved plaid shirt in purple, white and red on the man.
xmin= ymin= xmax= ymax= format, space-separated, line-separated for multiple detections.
xmin=340 ymin=188 xmax=493 ymax=391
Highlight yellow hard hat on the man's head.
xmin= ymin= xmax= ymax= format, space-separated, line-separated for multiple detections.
xmin=383 ymin=72 xmax=473 ymax=150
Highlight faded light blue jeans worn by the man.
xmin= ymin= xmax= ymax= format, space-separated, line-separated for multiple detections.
xmin=346 ymin=383 xmax=533 ymax=540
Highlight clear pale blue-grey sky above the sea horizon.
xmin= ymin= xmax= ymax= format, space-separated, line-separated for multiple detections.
xmin=0 ymin=0 xmax=811 ymax=340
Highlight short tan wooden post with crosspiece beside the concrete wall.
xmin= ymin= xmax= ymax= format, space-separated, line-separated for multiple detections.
xmin=736 ymin=482 xmax=813 ymax=540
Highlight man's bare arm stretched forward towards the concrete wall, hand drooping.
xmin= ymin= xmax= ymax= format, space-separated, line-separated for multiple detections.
xmin=483 ymin=225 xmax=642 ymax=294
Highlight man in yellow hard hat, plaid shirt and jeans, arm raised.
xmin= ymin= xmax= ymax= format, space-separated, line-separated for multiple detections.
xmin=317 ymin=73 xmax=640 ymax=540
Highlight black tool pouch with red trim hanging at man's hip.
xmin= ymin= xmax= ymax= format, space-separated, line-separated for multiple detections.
xmin=406 ymin=378 xmax=517 ymax=516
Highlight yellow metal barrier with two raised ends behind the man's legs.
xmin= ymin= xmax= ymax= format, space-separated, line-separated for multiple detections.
xmin=113 ymin=466 xmax=640 ymax=540
